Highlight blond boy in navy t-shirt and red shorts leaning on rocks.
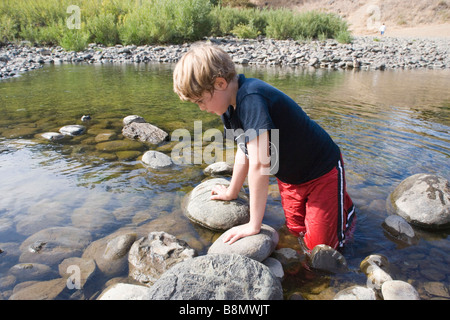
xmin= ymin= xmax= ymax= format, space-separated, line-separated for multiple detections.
xmin=173 ymin=44 xmax=354 ymax=250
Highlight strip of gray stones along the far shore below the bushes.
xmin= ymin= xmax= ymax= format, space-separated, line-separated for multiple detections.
xmin=0 ymin=37 xmax=450 ymax=79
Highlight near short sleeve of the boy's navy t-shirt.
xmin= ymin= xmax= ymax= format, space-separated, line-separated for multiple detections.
xmin=238 ymin=94 xmax=275 ymax=142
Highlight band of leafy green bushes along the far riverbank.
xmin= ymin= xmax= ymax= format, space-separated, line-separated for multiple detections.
xmin=0 ymin=0 xmax=351 ymax=51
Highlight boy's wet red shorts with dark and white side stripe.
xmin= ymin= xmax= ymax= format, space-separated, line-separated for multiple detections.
xmin=278 ymin=158 xmax=355 ymax=250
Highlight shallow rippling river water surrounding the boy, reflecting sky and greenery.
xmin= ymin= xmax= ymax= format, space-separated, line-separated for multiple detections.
xmin=0 ymin=64 xmax=450 ymax=299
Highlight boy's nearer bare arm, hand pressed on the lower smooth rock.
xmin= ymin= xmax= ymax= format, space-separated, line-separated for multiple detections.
xmin=223 ymin=132 xmax=270 ymax=244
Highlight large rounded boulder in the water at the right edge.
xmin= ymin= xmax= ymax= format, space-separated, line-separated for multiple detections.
xmin=386 ymin=173 xmax=450 ymax=229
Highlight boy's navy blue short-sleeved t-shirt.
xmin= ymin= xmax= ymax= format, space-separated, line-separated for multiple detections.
xmin=222 ymin=74 xmax=340 ymax=184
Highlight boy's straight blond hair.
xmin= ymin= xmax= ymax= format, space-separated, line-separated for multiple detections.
xmin=173 ymin=43 xmax=236 ymax=102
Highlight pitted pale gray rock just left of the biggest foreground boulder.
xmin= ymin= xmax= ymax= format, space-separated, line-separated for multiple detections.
xmin=128 ymin=232 xmax=196 ymax=285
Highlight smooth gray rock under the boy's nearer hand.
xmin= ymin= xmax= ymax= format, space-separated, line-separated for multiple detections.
xmin=208 ymin=224 xmax=279 ymax=262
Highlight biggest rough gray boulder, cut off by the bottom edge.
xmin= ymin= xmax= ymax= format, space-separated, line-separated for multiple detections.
xmin=149 ymin=254 xmax=283 ymax=300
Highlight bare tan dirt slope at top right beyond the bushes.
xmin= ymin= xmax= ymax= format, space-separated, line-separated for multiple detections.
xmin=250 ymin=0 xmax=450 ymax=38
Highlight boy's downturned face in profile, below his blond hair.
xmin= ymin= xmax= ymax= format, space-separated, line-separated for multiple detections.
xmin=194 ymin=78 xmax=236 ymax=116
